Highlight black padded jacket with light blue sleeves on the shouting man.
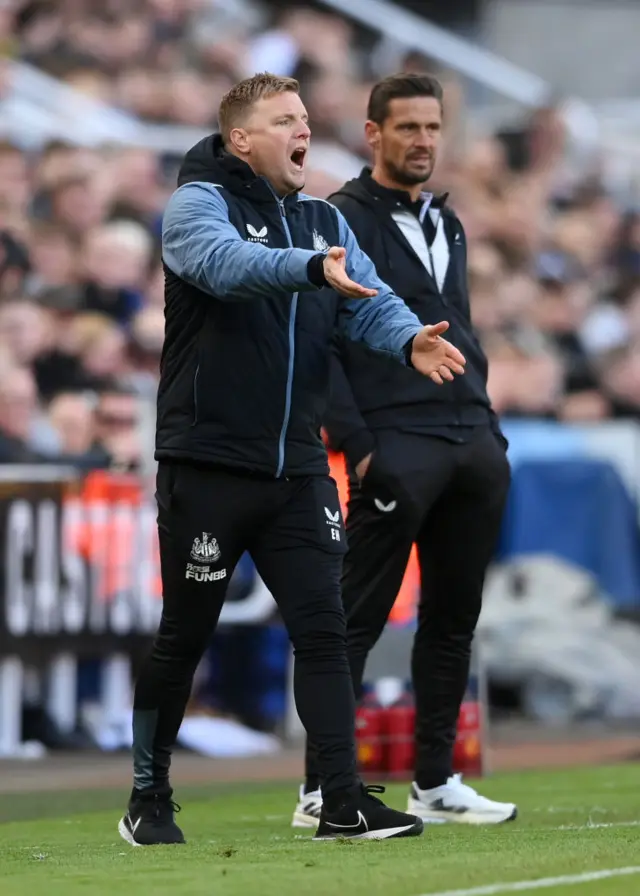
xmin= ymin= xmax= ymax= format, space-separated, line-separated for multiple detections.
xmin=155 ymin=136 xmax=421 ymax=477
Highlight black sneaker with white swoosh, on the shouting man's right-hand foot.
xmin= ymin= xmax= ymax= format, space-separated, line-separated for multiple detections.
xmin=313 ymin=785 xmax=424 ymax=840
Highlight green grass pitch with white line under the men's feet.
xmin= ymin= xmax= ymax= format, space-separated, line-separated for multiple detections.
xmin=0 ymin=764 xmax=640 ymax=896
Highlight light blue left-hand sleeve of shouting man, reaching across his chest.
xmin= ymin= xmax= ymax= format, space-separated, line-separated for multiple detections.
xmin=162 ymin=182 xmax=317 ymax=301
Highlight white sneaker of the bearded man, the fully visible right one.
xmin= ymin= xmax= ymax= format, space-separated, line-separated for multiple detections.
xmin=407 ymin=775 xmax=518 ymax=824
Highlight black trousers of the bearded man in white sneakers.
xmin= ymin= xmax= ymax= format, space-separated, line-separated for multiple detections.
xmin=307 ymin=426 xmax=510 ymax=788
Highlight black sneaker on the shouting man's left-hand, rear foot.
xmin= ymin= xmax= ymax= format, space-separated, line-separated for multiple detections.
xmin=118 ymin=787 xmax=185 ymax=846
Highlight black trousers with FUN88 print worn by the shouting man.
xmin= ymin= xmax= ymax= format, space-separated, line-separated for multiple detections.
xmin=133 ymin=463 xmax=358 ymax=792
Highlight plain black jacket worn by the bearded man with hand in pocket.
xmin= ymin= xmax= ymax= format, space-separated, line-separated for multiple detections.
xmin=325 ymin=168 xmax=503 ymax=465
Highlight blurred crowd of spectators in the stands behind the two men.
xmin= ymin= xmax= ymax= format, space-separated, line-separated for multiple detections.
xmin=0 ymin=0 xmax=640 ymax=469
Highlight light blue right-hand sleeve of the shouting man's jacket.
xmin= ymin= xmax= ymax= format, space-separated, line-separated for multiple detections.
xmin=335 ymin=209 xmax=423 ymax=363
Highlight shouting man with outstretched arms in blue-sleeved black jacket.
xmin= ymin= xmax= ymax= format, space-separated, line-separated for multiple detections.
xmin=119 ymin=74 xmax=465 ymax=845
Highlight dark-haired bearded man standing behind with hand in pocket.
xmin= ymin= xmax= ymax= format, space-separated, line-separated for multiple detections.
xmin=293 ymin=74 xmax=516 ymax=827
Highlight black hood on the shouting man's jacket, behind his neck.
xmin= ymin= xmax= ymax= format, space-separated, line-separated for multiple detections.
xmin=178 ymin=134 xmax=297 ymax=203
